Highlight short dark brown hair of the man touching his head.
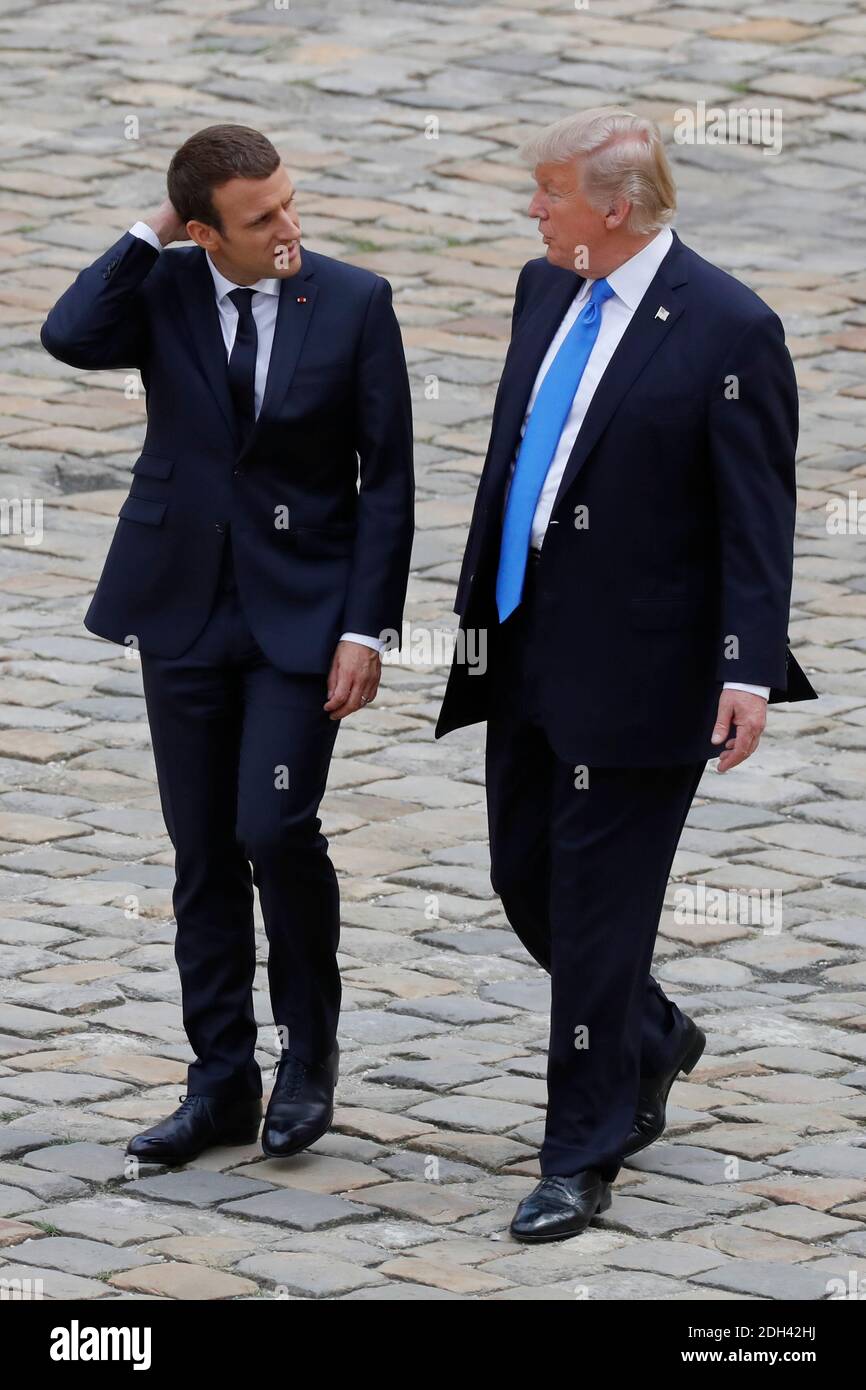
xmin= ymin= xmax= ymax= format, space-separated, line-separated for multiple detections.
xmin=167 ymin=125 xmax=279 ymax=232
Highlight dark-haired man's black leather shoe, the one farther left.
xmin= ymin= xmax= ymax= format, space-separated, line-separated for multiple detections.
xmin=126 ymin=1095 xmax=261 ymax=1163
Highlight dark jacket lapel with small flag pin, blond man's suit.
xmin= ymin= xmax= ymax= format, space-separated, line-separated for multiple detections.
xmin=550 ymin=232 xmax=688 ymax=516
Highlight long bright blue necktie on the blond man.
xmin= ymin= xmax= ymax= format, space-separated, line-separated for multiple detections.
xmin=496 ymin=279 xmax=613 ymax=623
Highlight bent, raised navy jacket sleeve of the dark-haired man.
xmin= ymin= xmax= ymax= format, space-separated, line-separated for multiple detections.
xmin=39 ymin=232 xmax=160 ymax=371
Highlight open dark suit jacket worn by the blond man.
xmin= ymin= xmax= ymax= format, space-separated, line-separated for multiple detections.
xmin=436 ymin=232 xmax=815 ymax=767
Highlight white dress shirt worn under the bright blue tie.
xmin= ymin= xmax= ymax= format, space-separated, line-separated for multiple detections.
xmin=503 ymin=227 xmax=770 ymax=699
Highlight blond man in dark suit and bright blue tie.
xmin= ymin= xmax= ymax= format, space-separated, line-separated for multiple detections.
xmin=436 ymin=107 xmax=815 ymax=1241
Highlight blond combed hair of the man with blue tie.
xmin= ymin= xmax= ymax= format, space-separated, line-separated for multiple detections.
xmin=520 ymin=106 xmax=677 ymax=236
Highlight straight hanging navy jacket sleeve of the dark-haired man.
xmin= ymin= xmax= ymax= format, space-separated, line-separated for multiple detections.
xmin=343 ymin=278 xmax=414 ymax=648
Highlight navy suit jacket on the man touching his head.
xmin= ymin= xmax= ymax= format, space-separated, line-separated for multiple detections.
xmin=42 ymin=232 xmax=414 ymax=673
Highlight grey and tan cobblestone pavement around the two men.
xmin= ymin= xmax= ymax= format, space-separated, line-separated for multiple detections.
xmin=0 ymin=0 xmax=866 ymax=1300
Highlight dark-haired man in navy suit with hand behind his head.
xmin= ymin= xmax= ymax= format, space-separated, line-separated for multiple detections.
xmin=42 ymin=125 xmax=414 ymax=1163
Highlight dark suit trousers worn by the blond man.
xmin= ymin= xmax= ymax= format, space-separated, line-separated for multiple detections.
xmin=487 ymin=547 xmax=706 ymax=1179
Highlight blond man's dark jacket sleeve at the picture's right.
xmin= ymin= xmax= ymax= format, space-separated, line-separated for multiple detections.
xmin=708 ymin=310 xmax=799 ymax=689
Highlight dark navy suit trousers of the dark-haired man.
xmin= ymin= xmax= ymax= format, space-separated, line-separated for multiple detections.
xmin=142 ymin=537 xmax=341 ymax=1097
